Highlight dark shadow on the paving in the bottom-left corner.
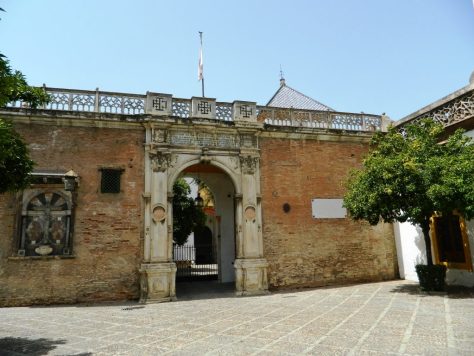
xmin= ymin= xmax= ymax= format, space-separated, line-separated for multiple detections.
xmin=0 ymin=337 xmax=91 ymax=356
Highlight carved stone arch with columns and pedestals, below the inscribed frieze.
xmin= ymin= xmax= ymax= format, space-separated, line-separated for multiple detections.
xmin=140 ymin=140 xmax=268 ymax=302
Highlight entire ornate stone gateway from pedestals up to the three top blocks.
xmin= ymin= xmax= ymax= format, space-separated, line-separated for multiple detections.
xmin=140 ymin=93 xmax=268 ymax=302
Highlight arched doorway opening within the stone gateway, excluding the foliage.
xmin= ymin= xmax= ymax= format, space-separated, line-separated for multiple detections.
xmin=173 ymin=164 xmax=236 ymax=290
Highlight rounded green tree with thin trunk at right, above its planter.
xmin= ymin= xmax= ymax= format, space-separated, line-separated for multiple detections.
xmin=344 ymin=120 xmax=474 ymax=265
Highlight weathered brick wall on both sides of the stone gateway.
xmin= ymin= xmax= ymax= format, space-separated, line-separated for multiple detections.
xmin=0 ymin=116 xmax=398 ymax=306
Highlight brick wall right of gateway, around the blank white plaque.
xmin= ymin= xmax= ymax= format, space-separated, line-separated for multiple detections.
xmin=260 ymin=138 xmax=398 ymax=288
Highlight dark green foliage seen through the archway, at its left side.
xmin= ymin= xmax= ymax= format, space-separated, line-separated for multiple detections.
xmin=173 ymin=178 xmax=206 ymax=245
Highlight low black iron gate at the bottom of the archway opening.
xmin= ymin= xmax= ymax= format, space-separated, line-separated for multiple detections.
xmin=173 ymin=245 xmax=218 ymax=281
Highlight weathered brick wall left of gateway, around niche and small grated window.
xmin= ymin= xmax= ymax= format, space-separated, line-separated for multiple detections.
xmin=0 ymin=124 xmax=144 ymax=305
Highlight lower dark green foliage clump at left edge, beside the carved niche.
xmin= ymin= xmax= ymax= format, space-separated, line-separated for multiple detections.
xmin=0 ymin=119 xmax=33 ymax=193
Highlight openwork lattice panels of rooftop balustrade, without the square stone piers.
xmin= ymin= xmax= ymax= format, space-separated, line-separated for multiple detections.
xmin=8 ymin=87 xmax=384 ymax=131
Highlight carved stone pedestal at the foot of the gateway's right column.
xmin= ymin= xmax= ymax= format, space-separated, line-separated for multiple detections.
xmin=234 ymin=258 xmax=268 ymax=295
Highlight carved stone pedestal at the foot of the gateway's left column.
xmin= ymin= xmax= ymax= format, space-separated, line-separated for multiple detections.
xmin=140 ymin=263 xmax=176 ymax=303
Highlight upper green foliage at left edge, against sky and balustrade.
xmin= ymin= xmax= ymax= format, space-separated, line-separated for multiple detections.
xmin=0 ymin=54 xmax=49 ymax=108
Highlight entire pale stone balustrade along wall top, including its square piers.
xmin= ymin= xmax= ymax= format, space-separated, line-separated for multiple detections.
xmin=8 ymin=86 xmax=388 ymax=132
